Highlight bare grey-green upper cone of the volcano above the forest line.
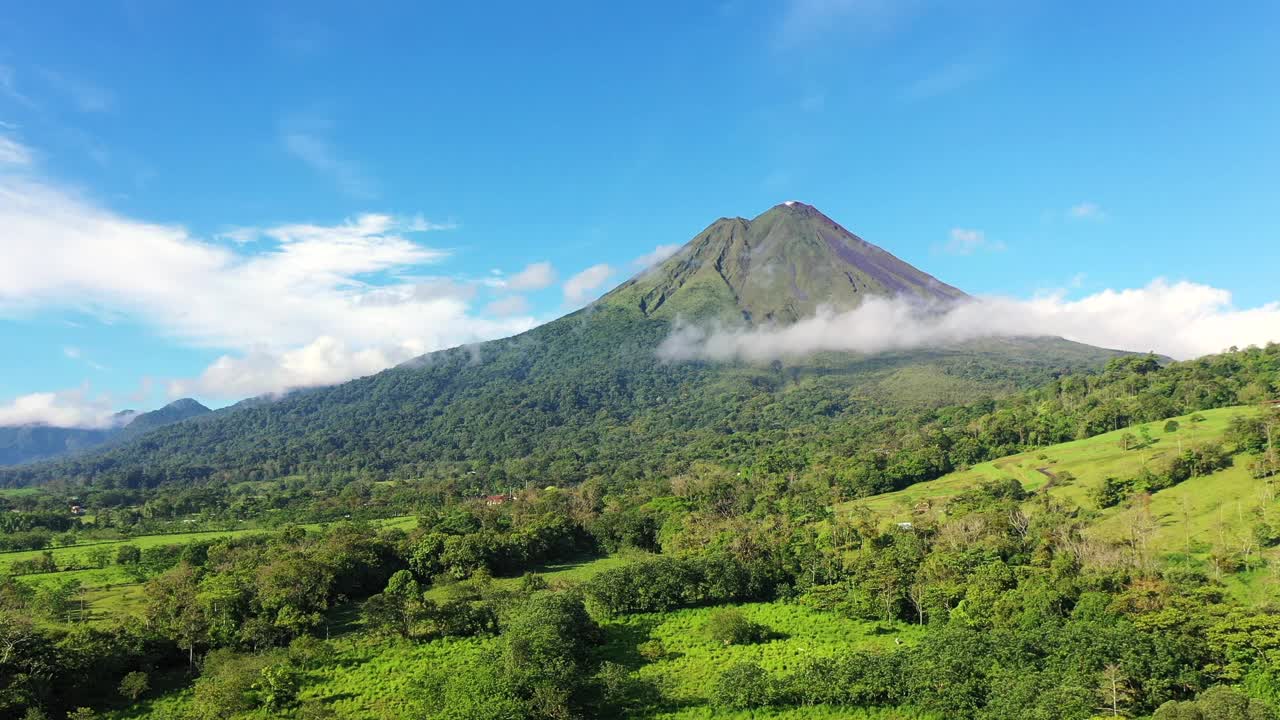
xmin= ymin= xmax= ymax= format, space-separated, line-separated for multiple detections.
xmin=605 ymin=200 xmax=965 ymax=324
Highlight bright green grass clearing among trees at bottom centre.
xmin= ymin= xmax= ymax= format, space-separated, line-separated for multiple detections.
xmin=602 ymin=602 xmax=924 ymax=717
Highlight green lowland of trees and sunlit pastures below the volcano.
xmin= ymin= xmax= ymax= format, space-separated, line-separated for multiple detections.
xmin=0 ymin=346 xmax=1280 ymax=720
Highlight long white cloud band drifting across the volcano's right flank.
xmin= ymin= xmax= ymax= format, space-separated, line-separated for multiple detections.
xmin=659 ymin=279 xmax=1280 ymax=363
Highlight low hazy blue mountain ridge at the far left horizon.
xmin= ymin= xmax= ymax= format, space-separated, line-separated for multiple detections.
xmin=0 ymin=397 xmax=210 ymax=465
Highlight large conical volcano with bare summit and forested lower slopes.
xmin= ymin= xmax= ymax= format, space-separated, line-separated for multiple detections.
xmin=0 ymin=202 xmax=1117 ymax=487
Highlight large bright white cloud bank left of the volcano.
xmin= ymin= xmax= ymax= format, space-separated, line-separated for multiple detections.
xmin=0 ymin=176 xmax=532 ymax=400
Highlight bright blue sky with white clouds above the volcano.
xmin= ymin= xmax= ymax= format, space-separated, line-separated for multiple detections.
xmin=0 ymin=0 xmax=1280 ymax=424
